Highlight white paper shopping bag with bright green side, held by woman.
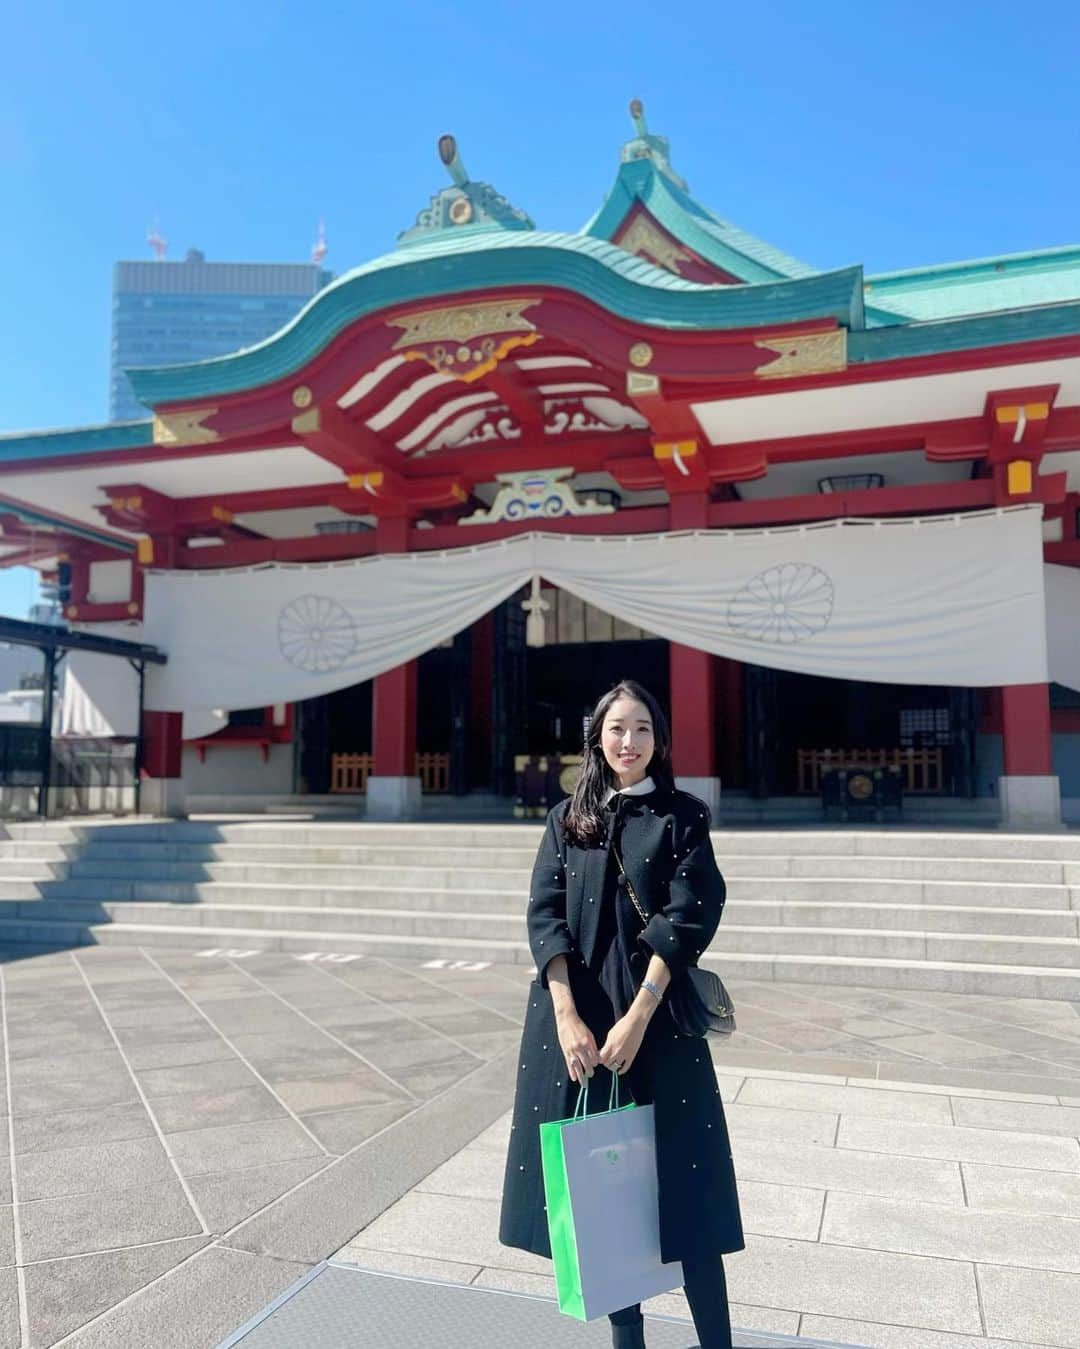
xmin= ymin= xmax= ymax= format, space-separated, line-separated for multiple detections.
xmin=539 ymin=1074 xmax=682 ymax=1321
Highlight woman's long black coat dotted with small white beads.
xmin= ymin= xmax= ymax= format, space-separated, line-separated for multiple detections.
xmin=499 ymin=786 xmax=746 ymax=1261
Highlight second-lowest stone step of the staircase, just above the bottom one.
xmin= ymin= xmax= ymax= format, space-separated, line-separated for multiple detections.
xmin=8 ymin=900 xmax=1080 ymax=971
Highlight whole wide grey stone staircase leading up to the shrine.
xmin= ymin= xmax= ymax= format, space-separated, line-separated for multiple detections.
xmin=0 ymin=820 xmax=1080 ymax=1001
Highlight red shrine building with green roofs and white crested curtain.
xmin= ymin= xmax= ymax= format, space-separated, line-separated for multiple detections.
xmin=0 ymin=101 xmax=1080 ymax=827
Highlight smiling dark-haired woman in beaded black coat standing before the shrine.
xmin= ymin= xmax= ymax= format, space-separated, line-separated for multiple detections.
xmin=499 ymin=680 xmax=746 ymax=1349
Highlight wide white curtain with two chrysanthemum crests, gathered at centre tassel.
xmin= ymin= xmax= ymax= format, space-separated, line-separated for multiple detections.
xmin=136 ymin=506 xmax=1046 ymax=710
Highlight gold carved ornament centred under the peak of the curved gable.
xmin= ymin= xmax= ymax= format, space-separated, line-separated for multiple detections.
xmin=387 ymin=299 xmax=539 ymax=384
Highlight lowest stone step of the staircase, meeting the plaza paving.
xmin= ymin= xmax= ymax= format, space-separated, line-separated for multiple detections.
xmin=0 ymin=919 xmax=1080 ymax=1017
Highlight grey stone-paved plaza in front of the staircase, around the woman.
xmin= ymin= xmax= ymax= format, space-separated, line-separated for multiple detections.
xmin=0 ymin=947 xmax=1080 ymax=1349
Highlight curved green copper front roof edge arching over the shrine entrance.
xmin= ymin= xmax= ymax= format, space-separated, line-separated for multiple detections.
xmin=127 ymin=231 xmax=863 ymax=407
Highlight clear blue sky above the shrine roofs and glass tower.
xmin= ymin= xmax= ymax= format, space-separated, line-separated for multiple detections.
xmin=0 ymin=0 xmax=1080 ymax=615
